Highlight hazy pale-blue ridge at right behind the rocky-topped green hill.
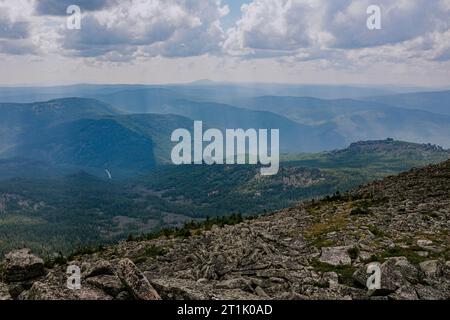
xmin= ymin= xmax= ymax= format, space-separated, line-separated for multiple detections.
xmin=230 ymin=96 xmax=450 ymax=148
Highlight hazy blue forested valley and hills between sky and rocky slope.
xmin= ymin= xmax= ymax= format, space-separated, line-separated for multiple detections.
xmin=0 ymin=83 xmax=450 ymax=257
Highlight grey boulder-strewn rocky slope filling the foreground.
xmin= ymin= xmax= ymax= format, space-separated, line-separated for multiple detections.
xmin=0 ymin=161 xmax=450 ymax=300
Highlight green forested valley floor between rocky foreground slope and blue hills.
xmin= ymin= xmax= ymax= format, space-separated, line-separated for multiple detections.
xmin=0 ymin=140 xmax=450 ymax=256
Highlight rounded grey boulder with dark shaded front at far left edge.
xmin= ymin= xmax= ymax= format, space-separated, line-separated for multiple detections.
xmin=3 ymin=249 xmax=45 ymax=282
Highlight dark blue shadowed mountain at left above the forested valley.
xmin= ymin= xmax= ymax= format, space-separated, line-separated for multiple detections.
xmin=0 ymin=98 xmax=191 ymax=176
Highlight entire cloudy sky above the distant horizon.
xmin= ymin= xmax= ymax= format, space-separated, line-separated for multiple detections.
xmin=0 ymin=0 xmax=450 ymax=87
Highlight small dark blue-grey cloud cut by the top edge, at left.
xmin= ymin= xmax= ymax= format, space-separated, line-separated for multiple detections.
xmin=35 ymin=0 xmax=116 ymax=16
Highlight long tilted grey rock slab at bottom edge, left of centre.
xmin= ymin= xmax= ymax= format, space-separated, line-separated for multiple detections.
xmin=116 ymin=259 xmax=161 ymax=300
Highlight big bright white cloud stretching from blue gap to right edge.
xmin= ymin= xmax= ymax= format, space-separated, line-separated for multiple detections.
xmin=224 ymin=0 xmax=450 ymax=55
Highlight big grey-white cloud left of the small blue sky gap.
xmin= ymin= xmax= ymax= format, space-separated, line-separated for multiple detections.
xmin=61 ymin=0 xmax=228 ymax=59
